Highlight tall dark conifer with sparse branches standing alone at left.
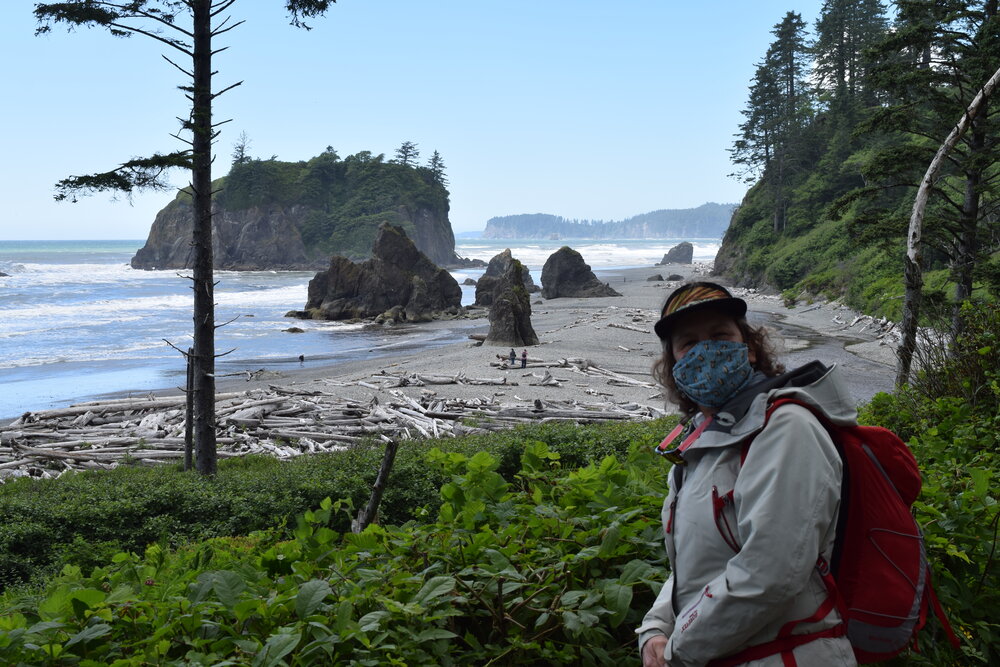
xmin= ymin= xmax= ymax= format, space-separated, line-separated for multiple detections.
xmin=34 ymin=0 xmax=336 ymax=475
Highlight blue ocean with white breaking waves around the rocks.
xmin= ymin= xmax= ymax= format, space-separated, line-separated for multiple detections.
xmin=0 ymin=239 xmax=719 ymax=419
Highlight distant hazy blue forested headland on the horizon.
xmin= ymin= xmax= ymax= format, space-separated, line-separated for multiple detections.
xmin=483 ymin=203 xmax=735 ymax=239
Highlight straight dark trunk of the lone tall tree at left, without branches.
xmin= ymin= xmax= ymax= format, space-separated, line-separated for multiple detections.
xmin=190 ymin=0 xmax=217 ymax=475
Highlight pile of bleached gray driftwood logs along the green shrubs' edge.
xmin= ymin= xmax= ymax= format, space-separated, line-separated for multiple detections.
xmin=0 ymin=374 xmax=661 ymax=482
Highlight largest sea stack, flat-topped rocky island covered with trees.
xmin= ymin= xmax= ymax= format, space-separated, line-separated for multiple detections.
xmin=132 ymin=145 xmax=457 ymax=270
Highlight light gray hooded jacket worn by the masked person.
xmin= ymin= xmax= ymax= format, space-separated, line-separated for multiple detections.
xmin=636 ymin=362 xmax=857 ymax=667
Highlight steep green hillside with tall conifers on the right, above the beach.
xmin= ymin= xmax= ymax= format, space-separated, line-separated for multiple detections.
xmin=716 ymin=0 xmax=1000 ymax=317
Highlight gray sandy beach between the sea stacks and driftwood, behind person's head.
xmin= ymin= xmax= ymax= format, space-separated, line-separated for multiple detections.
xmin=211 ymin=263 xmax=895 ymax=410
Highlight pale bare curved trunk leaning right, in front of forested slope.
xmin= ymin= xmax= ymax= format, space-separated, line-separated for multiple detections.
xmin=896 ymin=64 xmax=1000 ymax=387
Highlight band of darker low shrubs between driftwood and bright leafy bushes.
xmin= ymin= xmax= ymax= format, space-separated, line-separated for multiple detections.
xmin=0 ymin=421 xmax=665 ymax=588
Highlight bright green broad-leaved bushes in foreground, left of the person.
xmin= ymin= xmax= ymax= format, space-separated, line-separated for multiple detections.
xmin=0 ymin=442 xmax=666 ymax=665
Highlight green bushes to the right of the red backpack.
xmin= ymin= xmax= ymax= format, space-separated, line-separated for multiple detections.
xmin=861 ymin=303 xmax=1000 ymax=665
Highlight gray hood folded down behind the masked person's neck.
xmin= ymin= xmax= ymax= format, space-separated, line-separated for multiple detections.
xmin=691 ymin=361 xmax=858 ymax=450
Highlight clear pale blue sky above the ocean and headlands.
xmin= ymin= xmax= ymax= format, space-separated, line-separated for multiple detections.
xmin=0 ymin=0 xmax=821 ymax=239
